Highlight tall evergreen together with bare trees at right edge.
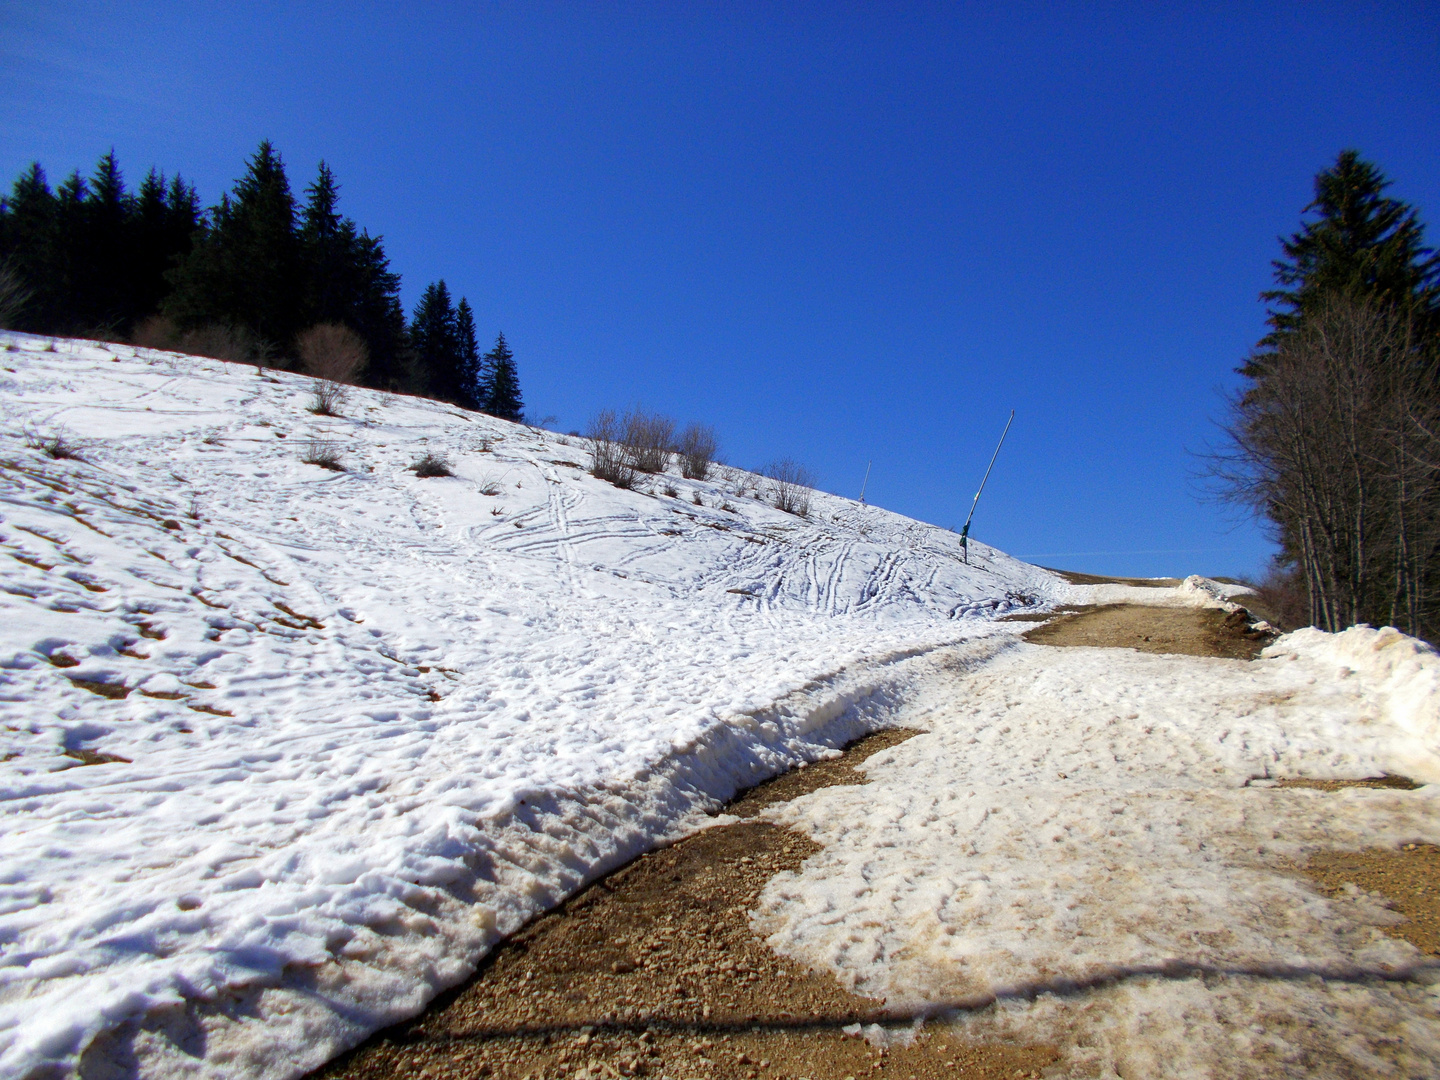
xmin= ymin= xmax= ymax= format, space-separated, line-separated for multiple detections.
xmin=1214 ymin=150 xmax=1440 ymax=641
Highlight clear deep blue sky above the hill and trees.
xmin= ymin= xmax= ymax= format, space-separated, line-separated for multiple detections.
xmin=0 ymin=1 xmax=1440 ymax=575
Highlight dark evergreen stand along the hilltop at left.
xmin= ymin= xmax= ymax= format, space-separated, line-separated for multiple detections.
xmin=0 ymin=143 xmax=523 ymax=419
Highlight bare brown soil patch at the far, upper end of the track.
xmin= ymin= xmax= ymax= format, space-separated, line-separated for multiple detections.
xmin=1025 ymin=603 xmax=1273 ymax=660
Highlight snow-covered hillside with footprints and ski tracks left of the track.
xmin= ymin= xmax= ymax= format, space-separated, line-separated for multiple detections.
xmin=0 ymin=334 xmax=1059 ymax=1077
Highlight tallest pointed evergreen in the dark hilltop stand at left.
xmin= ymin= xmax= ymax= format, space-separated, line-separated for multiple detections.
xmin=166 ymin=141 xmax=304 ymax=348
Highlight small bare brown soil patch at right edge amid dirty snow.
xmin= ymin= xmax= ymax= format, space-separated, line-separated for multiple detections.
xmin=1303 ymin=844 xmax=1440 ymax=956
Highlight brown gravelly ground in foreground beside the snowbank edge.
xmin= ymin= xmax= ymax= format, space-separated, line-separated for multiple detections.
xmin=312 ymin=732 xmax=1057 ymax=1080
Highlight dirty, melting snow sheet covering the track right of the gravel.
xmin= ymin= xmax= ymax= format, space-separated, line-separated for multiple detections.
xmin=755 ymin=626 xmax=1440 ymax=1077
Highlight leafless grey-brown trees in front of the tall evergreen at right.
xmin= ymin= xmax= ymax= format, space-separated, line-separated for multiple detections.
xmin=1210 ymin=297 xmax=1440 ymax=635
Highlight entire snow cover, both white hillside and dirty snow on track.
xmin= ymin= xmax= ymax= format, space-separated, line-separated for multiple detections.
xmin=0 ymin=334 xmax=1440 ymax=1079
